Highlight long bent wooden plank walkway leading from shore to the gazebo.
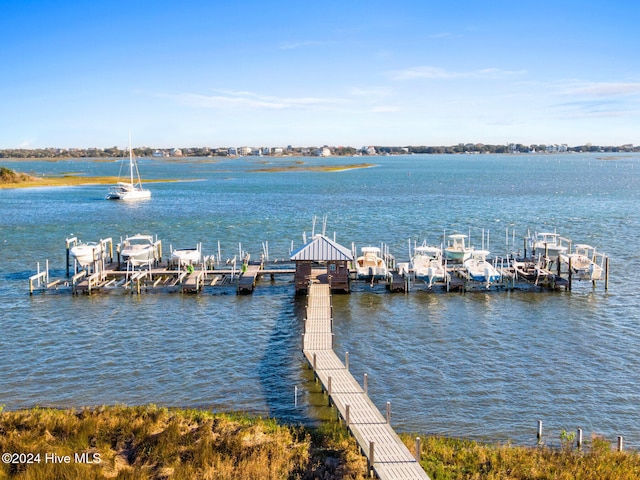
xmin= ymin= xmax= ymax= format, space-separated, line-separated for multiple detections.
xmin=302 ymin=283 xmax=429 ymax=480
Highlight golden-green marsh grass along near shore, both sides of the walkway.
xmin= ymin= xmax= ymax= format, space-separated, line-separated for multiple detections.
xmin=0 ymin=405 xmax=640 ymax=480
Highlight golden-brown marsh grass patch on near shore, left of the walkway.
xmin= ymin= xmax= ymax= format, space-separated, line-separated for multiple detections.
xmin=0 ymin=405 xmax=366 ymax=480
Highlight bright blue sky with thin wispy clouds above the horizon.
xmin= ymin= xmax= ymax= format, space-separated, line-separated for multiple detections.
xmin=0 ymin=0 xmax=640 ymax=148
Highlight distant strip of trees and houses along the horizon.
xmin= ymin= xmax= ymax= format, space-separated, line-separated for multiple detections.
xmin=0 ymin=143 xmax=640 ymax=159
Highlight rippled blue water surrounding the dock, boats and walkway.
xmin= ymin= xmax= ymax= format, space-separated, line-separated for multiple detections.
xmin=0 ymin=154 xmax=640 ymax=448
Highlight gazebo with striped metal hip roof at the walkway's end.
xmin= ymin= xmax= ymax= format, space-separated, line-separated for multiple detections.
xmin=291 ymin=235 xmax=353 ymax=293
